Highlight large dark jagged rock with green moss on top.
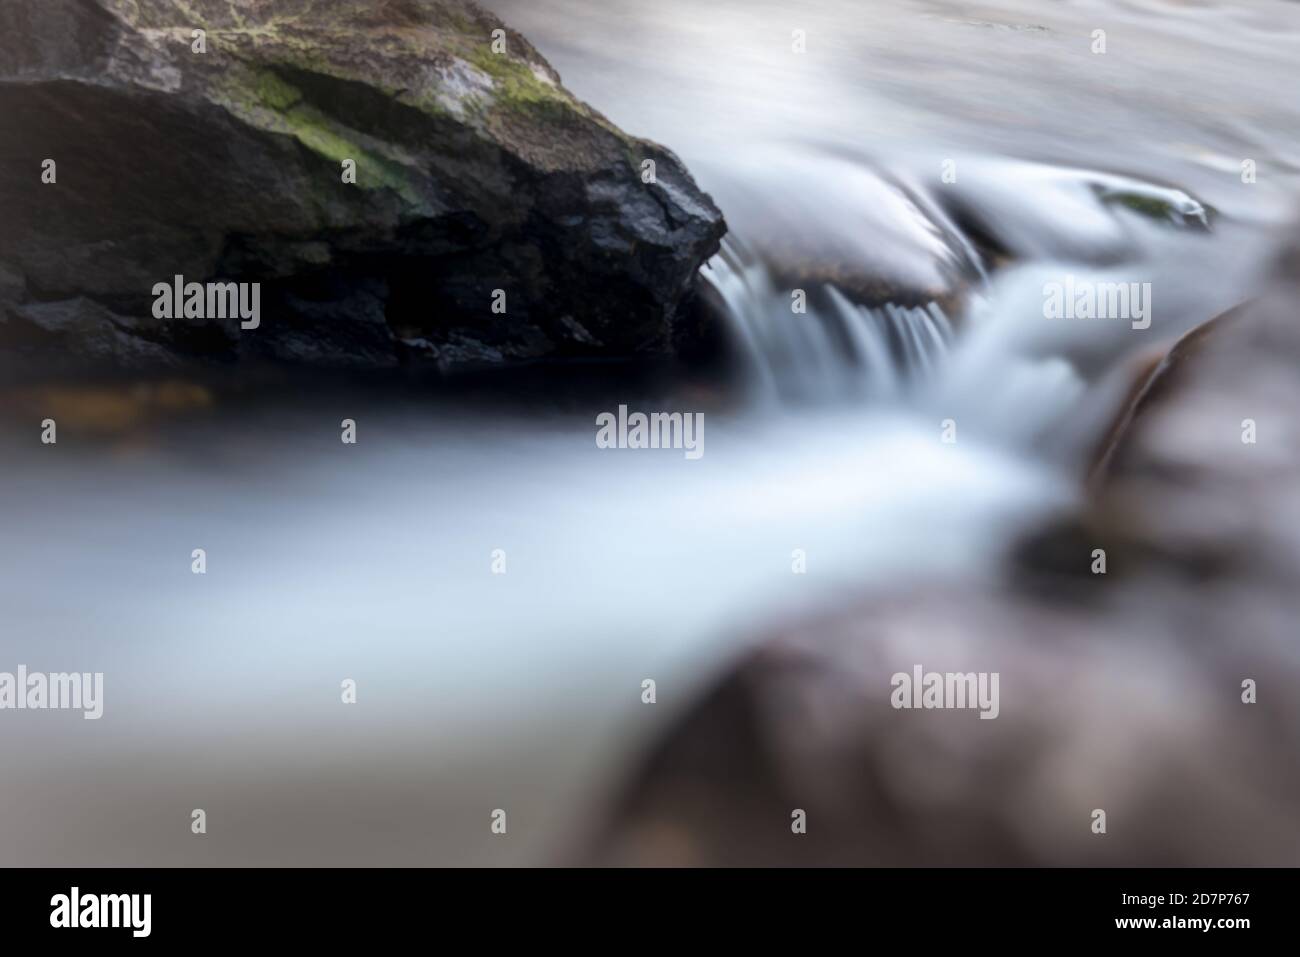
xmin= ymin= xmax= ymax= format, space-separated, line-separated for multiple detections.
xmin=0 ymin=0 xmax=725 ymax=379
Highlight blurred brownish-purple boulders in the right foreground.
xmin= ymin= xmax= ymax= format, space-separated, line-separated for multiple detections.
xmin=588 ymin=226 xmax=1300 ymax=866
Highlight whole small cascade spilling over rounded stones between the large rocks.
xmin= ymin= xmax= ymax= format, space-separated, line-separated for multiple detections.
xmin=701 ymin=151 xmax=1227 ymax=458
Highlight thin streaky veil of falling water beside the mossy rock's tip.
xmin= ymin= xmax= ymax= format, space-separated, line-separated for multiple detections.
xmin=701 ymin=237 xmax=953 ymax=400
